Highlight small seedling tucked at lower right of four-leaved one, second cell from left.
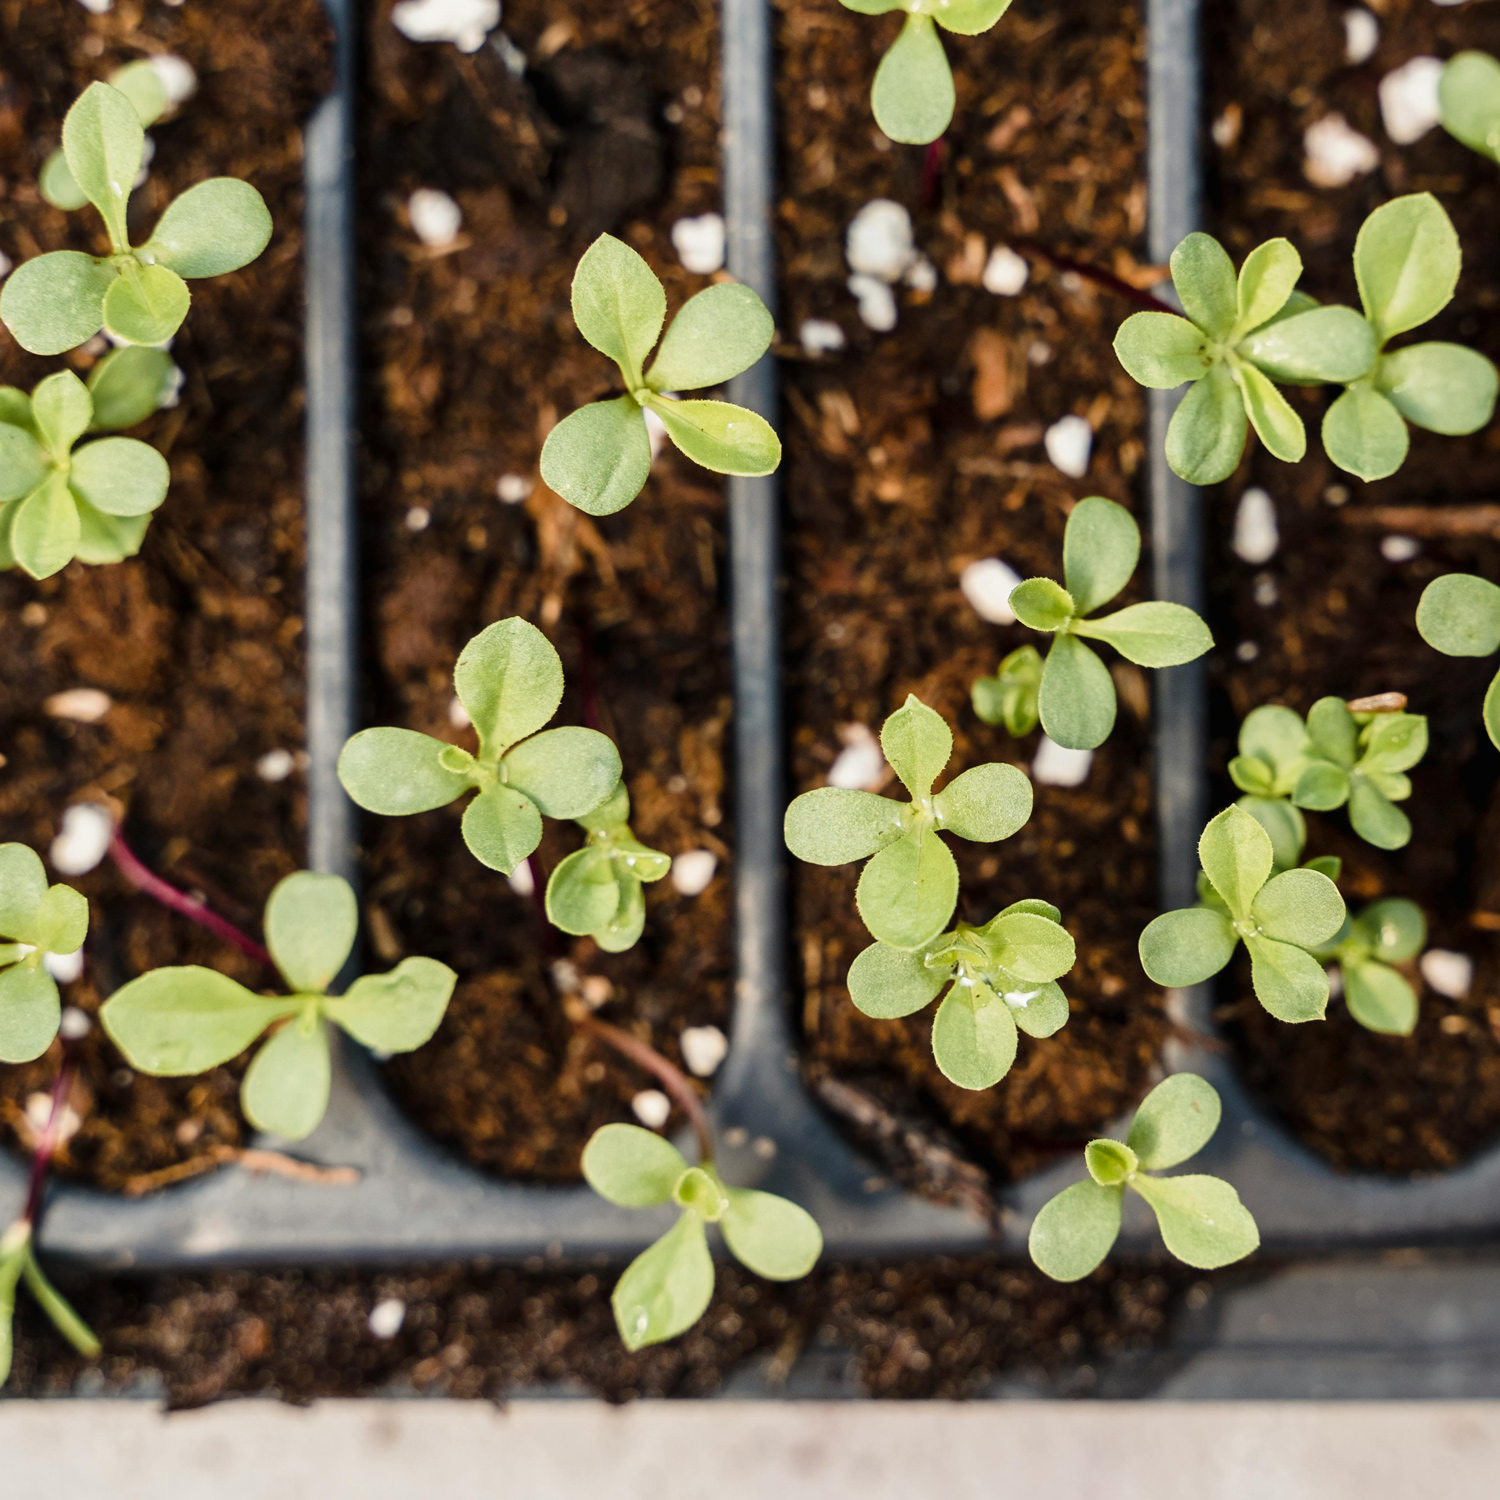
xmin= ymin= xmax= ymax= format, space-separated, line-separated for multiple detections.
xmin=546 ymin=783 xmax=672 ymax=953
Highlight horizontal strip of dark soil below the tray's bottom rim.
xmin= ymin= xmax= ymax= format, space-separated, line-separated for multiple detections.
xmin=8 ymin=1257 xmax=1194 ymax=1407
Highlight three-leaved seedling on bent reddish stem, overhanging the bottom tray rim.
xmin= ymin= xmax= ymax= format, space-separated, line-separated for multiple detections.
xmin=584 ymin=1125 xmax=824 ymax=1350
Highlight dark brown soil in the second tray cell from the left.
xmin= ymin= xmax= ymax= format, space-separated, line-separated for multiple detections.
xmin=360 ymin=0 xmax=732 ymax=1179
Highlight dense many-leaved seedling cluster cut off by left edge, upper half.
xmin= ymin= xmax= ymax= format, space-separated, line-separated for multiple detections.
xmin=0 ymin=369 xmax=171 ymax=578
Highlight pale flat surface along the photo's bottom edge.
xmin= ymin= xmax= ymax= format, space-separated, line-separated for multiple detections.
xmin=0 ymin=1401 xmax=1500 ymax=1500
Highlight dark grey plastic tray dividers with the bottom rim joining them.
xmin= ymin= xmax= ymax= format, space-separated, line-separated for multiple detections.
xmin=0 ymin=0 xmax=1500 ymax=1296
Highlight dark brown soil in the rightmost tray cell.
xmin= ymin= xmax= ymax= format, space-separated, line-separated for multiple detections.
xmin=1205 ymin=0 xmax=1500 ymax=1173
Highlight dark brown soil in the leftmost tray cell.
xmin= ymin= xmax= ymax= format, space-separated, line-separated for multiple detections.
xmin=0 ymin=0 xmax=330 ymax=1191
